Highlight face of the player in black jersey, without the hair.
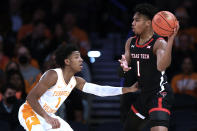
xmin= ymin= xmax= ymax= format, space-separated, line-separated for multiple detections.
xmin=132 ymin=13 xmax=150 ymax=35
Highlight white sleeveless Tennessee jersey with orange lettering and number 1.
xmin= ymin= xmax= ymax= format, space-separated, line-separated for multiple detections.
xmin=38 ymin=68 xmax=76 ymax=114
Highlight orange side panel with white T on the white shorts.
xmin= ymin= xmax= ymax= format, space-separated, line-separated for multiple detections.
xmin=22 ymin=102 xmax=40 ymax=131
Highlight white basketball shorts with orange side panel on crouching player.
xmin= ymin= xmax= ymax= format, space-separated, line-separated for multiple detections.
xmin=18 ymin=103 xmax=73 ymax=131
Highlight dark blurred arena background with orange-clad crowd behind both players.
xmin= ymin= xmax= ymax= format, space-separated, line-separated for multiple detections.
xmin=0 ymin=0 xmax=197 ymax=131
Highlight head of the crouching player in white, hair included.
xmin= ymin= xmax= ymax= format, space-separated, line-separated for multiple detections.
xmin=55 ymin=44 xmax=83 ymax=72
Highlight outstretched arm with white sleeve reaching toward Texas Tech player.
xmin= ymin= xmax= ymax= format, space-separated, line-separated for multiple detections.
xmin=76 ymin=77 xmax=138 ymax=97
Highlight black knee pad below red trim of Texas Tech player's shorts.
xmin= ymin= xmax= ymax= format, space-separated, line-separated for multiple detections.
xmin=150 ymin=111 xmax=170 ymax=128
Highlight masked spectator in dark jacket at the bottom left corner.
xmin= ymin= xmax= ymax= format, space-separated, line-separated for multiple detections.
xmin=0 ymin=84 xmax=21 ymax=131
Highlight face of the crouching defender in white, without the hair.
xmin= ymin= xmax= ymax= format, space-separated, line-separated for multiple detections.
xmin=69 ymin=51 xmax=83 ymax=72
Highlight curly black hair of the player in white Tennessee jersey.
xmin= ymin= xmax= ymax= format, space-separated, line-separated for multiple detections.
xmin=55 ymin=44 xmax=79 ymax=68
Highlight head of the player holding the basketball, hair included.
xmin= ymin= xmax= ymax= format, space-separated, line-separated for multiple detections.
xmin=132 ymin=3 xmax=157 ymax=35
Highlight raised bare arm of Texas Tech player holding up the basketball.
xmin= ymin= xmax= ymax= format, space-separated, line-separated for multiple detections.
xmin=153 ymin=23 xmax=179 ymax=71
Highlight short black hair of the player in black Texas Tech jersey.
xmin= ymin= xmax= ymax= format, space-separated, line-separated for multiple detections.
xmin=134 ymin=3 xmax=158 ymax=20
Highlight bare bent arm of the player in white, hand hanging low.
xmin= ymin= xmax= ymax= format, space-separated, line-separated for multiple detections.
xmin=27 ymin=70 xmax=60 ymax=128
